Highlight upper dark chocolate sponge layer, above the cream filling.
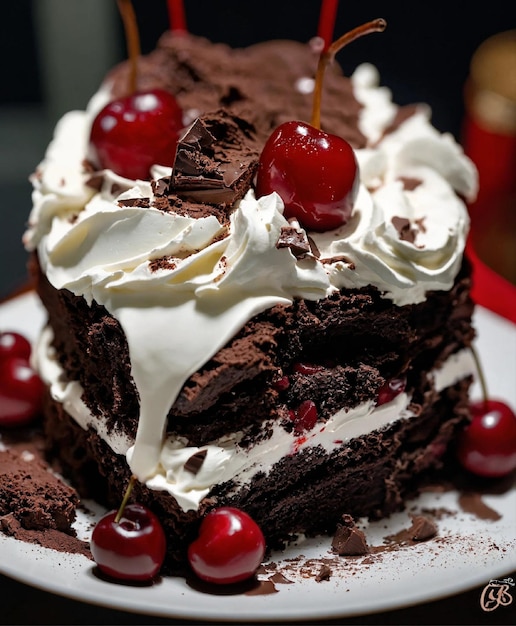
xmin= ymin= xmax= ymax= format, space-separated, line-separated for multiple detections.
xmin=29 ymin=251 xmax=474 ymax=445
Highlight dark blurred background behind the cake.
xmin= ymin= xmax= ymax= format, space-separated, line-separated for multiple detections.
xmin=0 ymin=0 xmax=516 ymax=297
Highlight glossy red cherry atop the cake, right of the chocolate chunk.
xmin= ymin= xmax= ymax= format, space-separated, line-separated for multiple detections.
xmin=256 ymin=121 xmax=360 ymax=231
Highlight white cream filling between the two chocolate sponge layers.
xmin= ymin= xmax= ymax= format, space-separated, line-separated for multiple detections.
xmin=34 ymin=329 xmax=476 ymax=511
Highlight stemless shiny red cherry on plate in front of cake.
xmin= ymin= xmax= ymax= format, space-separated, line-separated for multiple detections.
xmin=188 ymin=507 xmax=265 ymax=585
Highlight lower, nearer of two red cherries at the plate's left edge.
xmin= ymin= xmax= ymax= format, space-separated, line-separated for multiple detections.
xmin=0 ymin=356 xmax=44 ymax=427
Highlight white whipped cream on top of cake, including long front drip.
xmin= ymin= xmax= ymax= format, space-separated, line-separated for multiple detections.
xmin=24 ymin=66 xmax=477 ymax=496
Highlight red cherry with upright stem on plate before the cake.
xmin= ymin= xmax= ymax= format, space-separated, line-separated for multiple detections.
xmin=90 ymin=503 xmax=166 ymax=581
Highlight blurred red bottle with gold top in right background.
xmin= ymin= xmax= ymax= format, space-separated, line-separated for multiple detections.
xmin=462 ymin=30 xmax=516 ymax=322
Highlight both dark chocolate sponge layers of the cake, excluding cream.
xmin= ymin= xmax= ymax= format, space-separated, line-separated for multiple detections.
xmin=33 ymin=251 xmax=474 ymax=570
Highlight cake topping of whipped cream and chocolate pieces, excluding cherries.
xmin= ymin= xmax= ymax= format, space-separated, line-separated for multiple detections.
xmin=24 ymin=37 xmax=476 ymax=492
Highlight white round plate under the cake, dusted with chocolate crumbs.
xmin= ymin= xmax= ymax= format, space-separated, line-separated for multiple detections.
xmin=0 ymin=293 xmax=516 ymax=622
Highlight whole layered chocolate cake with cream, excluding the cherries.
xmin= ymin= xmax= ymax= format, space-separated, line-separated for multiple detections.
xmin=20 ymin=25 xmax=477 ymax=571
